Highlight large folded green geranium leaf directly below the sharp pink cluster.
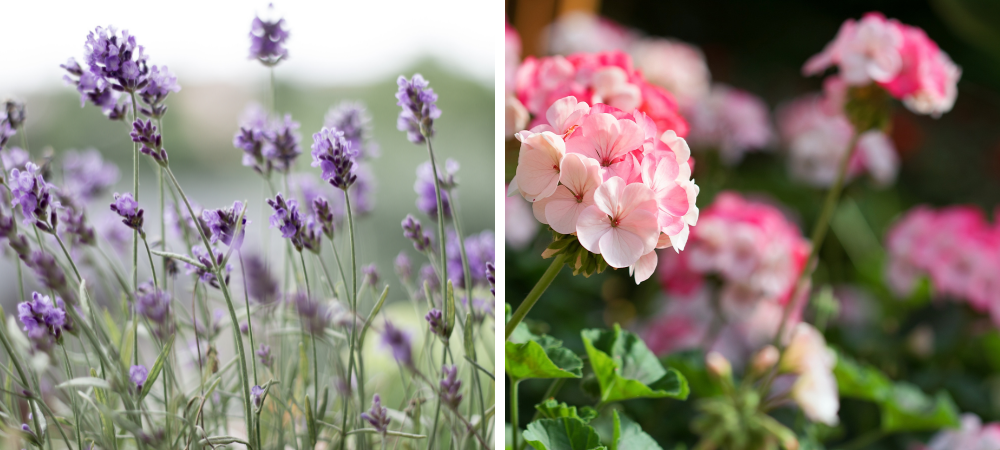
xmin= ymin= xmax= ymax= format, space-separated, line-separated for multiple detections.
xmin=580 ymin=324 xmax=689 ymax=403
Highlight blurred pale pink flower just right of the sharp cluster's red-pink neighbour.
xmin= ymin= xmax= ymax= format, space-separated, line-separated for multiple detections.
xmin=686 ymin=84 xmax=774 ymax=165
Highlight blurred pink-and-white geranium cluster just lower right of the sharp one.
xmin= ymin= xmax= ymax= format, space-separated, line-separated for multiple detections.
xmin=644 ymin=192 xmax=810 ymax=363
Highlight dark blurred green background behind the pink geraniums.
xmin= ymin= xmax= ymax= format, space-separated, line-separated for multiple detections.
xmin=506 ymin=0 xmax=1000 ymax=449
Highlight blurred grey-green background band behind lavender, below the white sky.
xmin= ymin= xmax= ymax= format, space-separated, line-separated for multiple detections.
xmin=0 ymin=59 xmax=495 ymax=310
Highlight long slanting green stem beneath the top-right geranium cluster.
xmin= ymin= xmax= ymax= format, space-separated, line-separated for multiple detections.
xmin=774 ymin=133 xmax=858 ymax=349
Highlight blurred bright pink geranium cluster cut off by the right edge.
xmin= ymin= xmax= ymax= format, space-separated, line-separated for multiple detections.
xmin=885 ymin=206 xmax=1000 ymax=318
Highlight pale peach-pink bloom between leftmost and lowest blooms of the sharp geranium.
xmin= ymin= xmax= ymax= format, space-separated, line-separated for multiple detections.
xmin=532 ymin=153 xmax=601 ymax=234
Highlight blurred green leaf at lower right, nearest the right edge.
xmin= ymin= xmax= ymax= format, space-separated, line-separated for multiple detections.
xmin=882 ymin=382 xmax=959 ymax=432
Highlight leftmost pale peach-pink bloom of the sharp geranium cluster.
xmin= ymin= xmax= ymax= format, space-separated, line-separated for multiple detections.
xmin=507 ymin=131 xmax=566 ymax=202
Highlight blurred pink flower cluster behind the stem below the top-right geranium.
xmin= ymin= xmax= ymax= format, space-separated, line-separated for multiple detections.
xmin=777 ymin=76 xmax=899 ymax=187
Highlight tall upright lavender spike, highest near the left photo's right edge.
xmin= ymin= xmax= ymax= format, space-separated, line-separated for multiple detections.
xmin=396 ymin=73 xmax=441 ymax=144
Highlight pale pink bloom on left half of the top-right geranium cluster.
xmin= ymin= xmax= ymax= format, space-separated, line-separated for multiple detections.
xmin=802 ymin=13 xmax=903 ymax=85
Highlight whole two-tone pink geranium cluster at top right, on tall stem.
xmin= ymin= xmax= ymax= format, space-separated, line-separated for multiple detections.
xmin=802 ymin=12 xmax=962 ymax=117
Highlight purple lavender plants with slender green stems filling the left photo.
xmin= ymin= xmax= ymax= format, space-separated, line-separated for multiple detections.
xmin=0 ymin=10 xmax=495 ymax=450
